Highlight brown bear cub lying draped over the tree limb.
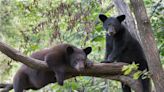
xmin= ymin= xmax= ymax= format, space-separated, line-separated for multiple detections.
xmin=13 ymin=44 xmax=92 ymax=92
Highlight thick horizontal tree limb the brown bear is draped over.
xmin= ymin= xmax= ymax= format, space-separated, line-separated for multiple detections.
xmin=0 ymin=42 xmax=142 ymax=92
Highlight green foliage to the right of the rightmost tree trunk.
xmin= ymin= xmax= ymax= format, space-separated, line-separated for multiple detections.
xmin=150 ymin=0 xmax=164 ymax=64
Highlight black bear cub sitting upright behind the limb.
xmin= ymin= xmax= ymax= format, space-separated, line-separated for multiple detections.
xmin=99 ymin=14 xmax=150 ymax=92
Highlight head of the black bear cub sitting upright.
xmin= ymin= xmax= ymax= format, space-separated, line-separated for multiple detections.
xmin=99 ymin=14 xmax=125 ymax=36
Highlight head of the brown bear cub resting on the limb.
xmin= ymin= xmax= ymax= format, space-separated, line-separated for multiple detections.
xmin=66 ymin=46 xmax=92 ymax=71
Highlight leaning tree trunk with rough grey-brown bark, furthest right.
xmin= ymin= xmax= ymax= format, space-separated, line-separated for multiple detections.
xmin=130 ymin=0 xmax=164 ymax=92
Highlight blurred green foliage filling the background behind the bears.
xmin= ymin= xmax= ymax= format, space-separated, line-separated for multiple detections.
xmin=0 ymin=0 xmax=164 ymax=92
